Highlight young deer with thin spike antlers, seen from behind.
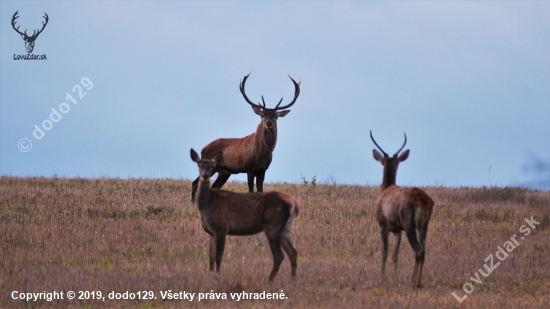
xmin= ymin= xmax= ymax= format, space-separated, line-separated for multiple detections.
xmin=370 ymin=131 xmax=434 ymax=287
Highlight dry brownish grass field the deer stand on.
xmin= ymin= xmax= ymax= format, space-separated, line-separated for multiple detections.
xmin=0 ymin=177 xmax=550 ymax=308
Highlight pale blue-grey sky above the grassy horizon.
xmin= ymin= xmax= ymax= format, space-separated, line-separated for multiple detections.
xmin=0 ymin=1 xmax=550 ymax=186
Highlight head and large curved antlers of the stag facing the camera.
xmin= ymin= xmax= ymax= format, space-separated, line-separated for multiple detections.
xmin=239 ymin=73 xmax=300 ymax=133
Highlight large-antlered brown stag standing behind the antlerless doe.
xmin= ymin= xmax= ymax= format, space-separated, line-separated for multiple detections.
xmin=191 ymin=73 xmax=300 ymax=201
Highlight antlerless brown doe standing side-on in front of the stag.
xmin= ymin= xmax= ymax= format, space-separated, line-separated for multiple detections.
xmin=191 ymin=149 xmax=298 ymax=281
